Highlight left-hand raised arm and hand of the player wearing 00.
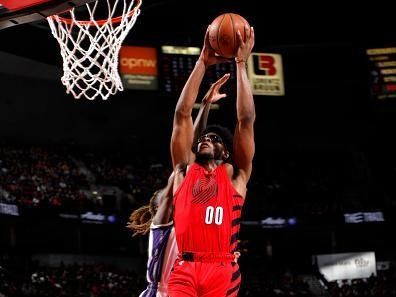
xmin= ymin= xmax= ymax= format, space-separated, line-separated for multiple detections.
xmin=171 ymin=27 xmax=232 ymax=168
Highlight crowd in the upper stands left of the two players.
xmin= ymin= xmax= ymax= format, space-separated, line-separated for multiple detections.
xmin=0 ymin=145 xmax=169 ymax=212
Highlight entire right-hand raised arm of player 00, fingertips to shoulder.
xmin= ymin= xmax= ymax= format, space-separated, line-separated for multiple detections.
xmin=234 ymin=27 xmax=256 ymax=190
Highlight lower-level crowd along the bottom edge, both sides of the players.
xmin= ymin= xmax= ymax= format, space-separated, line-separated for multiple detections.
xmin=0 ymin=258 xmax=396 ymax=297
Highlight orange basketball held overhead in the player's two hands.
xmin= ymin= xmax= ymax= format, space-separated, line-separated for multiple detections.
xmin=209 ymin=13 xmax=250 ymax=58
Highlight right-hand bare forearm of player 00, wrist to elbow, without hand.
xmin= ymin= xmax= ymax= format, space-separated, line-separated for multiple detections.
xmin=236 ymin=62 xmax=256 ymax=123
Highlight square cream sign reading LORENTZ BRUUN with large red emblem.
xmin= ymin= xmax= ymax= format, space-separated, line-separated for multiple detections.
xmin=248 ymin=53 xmax=285 ymax=96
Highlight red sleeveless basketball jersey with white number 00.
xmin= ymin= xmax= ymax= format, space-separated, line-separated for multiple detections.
xmin=174 ymin=163 xmax=244 ymax=253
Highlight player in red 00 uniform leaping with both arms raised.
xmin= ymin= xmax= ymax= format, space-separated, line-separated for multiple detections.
xmin=168 ymin=23 xmax=255 ymax=297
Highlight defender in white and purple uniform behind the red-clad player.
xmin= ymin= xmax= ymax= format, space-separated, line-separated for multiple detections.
xmin=127 ymin=74 xmax=230 ymax=297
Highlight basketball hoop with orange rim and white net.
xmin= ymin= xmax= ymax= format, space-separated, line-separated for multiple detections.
xmin=47 ymin=0 xmax=142 ymax=100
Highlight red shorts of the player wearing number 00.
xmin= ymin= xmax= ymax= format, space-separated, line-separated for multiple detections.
xmin=168 ymin=252 xmax=234 ymax=297
